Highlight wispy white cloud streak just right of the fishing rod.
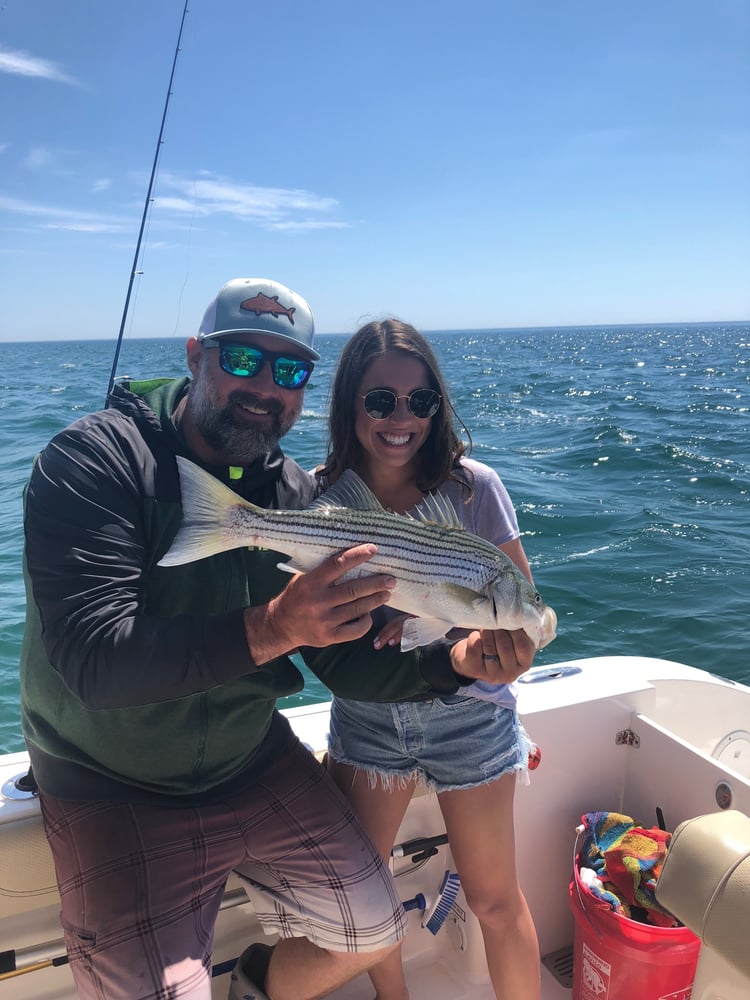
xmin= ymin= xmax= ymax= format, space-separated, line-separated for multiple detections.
xmin=156 ymin=174 xmax=349 ymax=230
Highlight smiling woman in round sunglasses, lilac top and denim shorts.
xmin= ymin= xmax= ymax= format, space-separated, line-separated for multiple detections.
xmin=319 ymin=319 xmax=540 ymax=1000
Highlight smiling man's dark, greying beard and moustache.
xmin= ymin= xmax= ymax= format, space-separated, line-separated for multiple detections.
xmin=190 ymin=379 xmax=302 ymax=465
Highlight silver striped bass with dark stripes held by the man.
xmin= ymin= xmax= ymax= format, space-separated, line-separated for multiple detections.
xmin=159 ymin=457 xmax=557 ymax=650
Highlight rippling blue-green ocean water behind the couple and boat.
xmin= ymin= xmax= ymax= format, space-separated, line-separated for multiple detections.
xmin=0 ymin=322 xmax=750 ymax=752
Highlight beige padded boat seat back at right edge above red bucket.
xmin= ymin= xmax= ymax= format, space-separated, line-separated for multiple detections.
xmin=656 ymin=810 xmax=750 ymax=977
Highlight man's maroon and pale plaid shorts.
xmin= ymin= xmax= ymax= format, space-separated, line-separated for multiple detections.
xmin=40 ymin=745 xmax=405 ymax=1000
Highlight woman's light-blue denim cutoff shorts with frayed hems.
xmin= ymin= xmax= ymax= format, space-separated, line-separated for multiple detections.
xmin=328 ymin=695 xmax=531 ymax=792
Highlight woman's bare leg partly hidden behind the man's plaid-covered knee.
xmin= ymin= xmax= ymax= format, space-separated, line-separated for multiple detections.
xmin=327 ymin=757 xmax=416 ymax=1000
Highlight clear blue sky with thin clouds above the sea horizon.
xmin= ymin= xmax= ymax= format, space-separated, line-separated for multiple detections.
xmin=0 ymin=0 xmax=750 ymax=340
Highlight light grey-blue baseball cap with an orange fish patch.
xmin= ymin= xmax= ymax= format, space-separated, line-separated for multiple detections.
xmin=198 ymin=278 xmax=320 ymax=361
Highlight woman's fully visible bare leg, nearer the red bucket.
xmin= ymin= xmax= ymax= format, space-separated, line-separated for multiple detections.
xmin=438 ymin=773 xmax=541 ymax=1000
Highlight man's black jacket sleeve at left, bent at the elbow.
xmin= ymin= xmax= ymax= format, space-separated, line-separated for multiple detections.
xmin=24 ymin=418 xmax=253 ymax=709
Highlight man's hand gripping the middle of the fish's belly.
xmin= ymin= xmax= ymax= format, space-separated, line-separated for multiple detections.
xmin=245 ymin=545 xmax=396 ymax=664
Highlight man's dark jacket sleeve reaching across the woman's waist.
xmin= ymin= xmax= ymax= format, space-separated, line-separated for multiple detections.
xmin=300 ymin=627 xmax=468 ymax=702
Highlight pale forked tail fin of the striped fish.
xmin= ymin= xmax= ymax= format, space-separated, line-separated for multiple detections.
xmin=158 ymin=456 xmax=253 ymax=566
